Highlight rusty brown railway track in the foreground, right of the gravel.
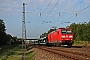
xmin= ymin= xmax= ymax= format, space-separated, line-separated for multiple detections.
xmin=37 ymin=46 xmax=90 ymax=60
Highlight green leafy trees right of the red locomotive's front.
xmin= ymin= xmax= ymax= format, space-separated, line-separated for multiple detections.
xmin=70 ymin=22 xmax=90 ymax=41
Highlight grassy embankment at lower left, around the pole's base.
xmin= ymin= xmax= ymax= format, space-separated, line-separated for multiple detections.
xmin=0 ymin=45 xmax=34 ymax=60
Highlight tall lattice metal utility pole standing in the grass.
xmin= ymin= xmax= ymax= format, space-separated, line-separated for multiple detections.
xmin=22 ymin=3 xmax=26 ymax=60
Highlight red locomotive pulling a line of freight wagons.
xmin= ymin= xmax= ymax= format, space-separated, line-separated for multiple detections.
xmin=34 ymin=28 xmax=74 ymax=47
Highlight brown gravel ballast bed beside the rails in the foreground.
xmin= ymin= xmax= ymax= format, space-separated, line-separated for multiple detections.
xmin=32 ymin=48 xmax=70 ymax=60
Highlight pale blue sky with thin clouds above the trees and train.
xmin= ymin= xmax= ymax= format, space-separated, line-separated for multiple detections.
xmin=0 ymin=0 xmax=90 ymax=38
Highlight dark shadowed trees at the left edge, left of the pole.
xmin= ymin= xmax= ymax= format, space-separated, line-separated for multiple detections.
xmin=0 ymin=19 xmax=21 ymax=46
